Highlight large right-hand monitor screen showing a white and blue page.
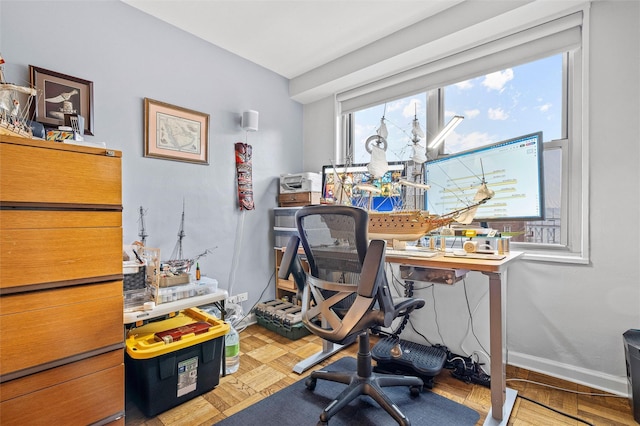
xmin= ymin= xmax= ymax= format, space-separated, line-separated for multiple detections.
xmin=425 ymin=132 xmax=544 ymax=222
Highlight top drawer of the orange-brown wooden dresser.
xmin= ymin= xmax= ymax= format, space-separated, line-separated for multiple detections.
xmin=0 ymin=141 xmax=122 ymax=210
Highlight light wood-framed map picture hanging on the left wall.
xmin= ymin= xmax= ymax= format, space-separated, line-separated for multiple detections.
xmin=144 ymin=98 xmax=209 ymax=164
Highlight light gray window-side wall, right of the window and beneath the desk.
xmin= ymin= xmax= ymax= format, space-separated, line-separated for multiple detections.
xmin=304 ymin=1 xmax=640 ymax=394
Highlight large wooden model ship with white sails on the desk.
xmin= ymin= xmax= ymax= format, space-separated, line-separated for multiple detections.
xmin=336 ymin=108 xmax=494 ymax=241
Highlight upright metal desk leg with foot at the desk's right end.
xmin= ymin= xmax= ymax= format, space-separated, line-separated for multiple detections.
xmin=483 ymin=271 xmax=517 ymax=425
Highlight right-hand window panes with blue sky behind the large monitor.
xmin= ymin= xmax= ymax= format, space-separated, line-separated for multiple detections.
xmin=443 ymin=54 xmax=567 ymax=244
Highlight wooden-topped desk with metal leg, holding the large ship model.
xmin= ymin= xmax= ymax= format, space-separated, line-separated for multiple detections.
xmin=386 ymin=252 xmax=523 ymax=425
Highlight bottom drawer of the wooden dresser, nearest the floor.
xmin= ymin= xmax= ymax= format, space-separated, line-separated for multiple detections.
xmin=0 ymin=349 xmax=124 ymax=425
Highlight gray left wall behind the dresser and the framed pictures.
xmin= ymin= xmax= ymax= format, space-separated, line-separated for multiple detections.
xmin=0 ymin=0 xmax=302 ymax=309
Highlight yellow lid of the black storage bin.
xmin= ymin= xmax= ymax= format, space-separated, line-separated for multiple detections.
xmin=126 ymin=308 xmax=229 ymax=359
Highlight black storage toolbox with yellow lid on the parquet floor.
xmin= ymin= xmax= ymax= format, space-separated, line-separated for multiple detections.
xmin=125 ymin=308 xmax=229 ymax=417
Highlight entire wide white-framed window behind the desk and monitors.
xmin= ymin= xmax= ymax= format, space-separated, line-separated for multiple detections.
xmin=337 ymin=11 xmax=588 ymax=262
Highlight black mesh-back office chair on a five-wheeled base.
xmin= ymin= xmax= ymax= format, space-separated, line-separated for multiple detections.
xmin=278 ymin=205 xmax=424 ymax=425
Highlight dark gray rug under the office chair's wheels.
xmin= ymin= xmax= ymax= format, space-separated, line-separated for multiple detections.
xmin=217 ymin=357 xmax=480 ymax=426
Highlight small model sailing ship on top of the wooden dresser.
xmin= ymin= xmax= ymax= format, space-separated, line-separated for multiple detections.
xmin=0 ymin=56 xmax=37 ymax=139
